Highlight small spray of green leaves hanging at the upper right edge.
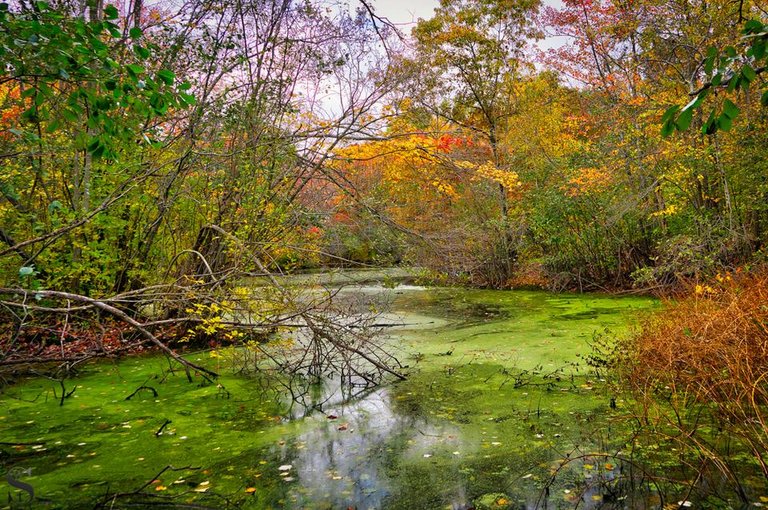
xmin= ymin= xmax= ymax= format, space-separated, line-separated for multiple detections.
xmin=661 ymin=20 xmax=768 ymax=137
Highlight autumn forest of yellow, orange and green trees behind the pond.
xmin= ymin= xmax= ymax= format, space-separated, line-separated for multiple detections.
xmin=0 ymin=0 xmax=768 ymax=372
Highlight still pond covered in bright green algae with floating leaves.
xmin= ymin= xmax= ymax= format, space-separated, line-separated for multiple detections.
xmin=0 ymin=284 xmax=655 ymax=509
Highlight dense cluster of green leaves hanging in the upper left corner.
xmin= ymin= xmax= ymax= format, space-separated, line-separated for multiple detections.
xmin=0 ymin=2 xmax=195 ymax=159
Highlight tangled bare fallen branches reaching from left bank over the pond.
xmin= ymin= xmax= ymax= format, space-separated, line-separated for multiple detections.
xmin=0 ymin=249 xmax=403 ymax=396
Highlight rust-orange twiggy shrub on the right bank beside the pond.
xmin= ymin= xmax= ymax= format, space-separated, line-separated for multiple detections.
xmin=619 ymin=269 xmax=768 ymax=486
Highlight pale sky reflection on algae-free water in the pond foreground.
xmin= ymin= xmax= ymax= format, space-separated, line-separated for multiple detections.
xmin=280 ymin=386 xmax=460 ymax=509
